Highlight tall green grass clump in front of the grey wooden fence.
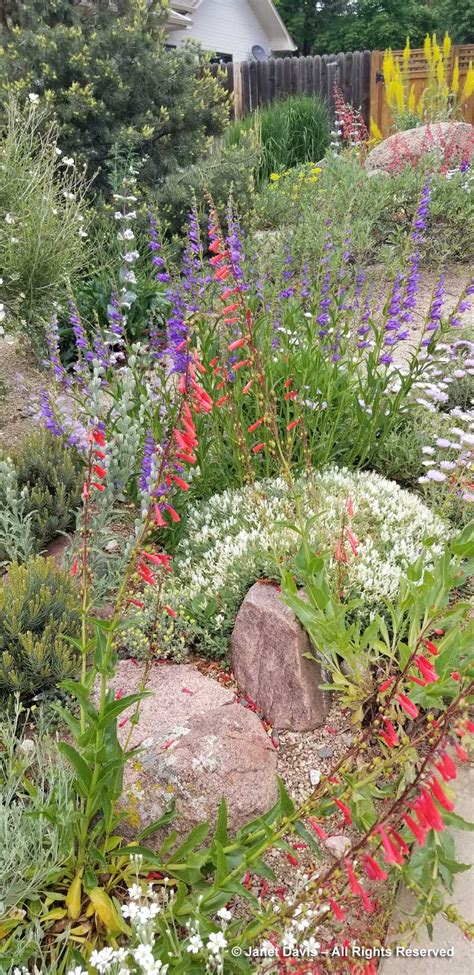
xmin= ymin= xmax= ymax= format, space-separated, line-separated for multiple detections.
xmin=225 ymin=95 xmax=330 ymax=183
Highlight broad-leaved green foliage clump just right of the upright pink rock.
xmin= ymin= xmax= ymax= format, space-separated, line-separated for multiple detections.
xmin=282 ymin=522 xmax=474 ymax=723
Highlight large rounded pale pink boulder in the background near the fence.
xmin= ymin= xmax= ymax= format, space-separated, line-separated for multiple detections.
xmin=366 ymin=122 xmax=474 ymax=172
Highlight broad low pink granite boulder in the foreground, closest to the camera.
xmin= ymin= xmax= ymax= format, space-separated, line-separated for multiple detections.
xmin=107 ymin=661 xmax=277 ymax=846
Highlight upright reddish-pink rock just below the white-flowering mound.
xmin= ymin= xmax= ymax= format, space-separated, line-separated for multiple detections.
xmin=231 ymin=582 xmax=330 ymax=731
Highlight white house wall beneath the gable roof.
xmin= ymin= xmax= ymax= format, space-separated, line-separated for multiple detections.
xmin=170 ymin=0 xmax=270 ymax=61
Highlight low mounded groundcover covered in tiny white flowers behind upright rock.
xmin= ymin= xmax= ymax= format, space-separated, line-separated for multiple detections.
xmin=135 ymin=467 xmax=449 ymax=656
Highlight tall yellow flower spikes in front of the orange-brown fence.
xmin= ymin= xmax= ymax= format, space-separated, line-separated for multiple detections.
xmin=383 ymin=33 xmax=474 ymax=130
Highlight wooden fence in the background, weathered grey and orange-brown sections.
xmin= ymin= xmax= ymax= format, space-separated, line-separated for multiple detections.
xmin=212 ymin=44 xmax=474 ymax=136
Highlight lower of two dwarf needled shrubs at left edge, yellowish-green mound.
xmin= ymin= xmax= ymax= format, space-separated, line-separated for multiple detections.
xmin=0 ymin=557 xmax=79 ymax=697
